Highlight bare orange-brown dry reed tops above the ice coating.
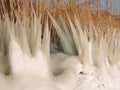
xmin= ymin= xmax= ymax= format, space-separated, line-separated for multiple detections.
xmin=0 ymin=0 xmax=120 ymax=47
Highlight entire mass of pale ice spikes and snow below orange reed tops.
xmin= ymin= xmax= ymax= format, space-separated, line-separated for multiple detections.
xmin=0 ymin=13 xmax=120 ymax=90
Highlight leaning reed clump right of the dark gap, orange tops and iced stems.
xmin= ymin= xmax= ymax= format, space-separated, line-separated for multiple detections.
xmin=49 ymin=0 xmax=120 ymax=68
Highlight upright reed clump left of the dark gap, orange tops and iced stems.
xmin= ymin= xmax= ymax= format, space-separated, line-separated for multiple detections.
xmin=0 ymin=0 xmax=50 ymax=75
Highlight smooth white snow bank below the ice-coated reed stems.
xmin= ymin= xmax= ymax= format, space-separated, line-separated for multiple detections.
xmin=0 ymin=41 xmax=120 ymax=90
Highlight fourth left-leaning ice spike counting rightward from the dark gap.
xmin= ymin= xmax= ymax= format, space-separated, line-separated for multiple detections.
xmin=75 ymin=16 xmax=90 ymax=64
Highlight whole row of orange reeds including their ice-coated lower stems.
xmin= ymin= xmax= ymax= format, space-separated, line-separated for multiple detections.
xmin=0 ymin=0 xmax=120 ymax=76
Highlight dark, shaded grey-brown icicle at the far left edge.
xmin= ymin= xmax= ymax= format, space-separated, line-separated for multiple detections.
xmin=0 ymin=16 xmax=10 ymax=75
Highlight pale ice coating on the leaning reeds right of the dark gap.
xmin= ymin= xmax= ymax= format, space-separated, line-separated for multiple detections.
xmin=49 ymin=14 xmax=120 ymax=68
